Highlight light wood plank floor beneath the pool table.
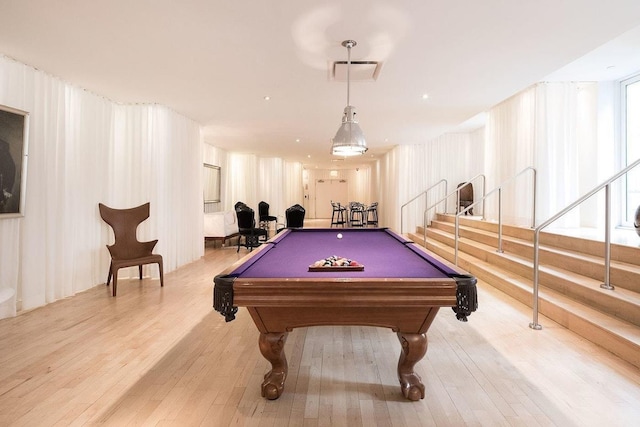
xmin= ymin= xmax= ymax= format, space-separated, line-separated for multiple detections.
xmin=0 ymin=236 xmax=640 ymax=427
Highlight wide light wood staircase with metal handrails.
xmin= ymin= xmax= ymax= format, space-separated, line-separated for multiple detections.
xmin=409 ymin=214 xmax=640 ymax=367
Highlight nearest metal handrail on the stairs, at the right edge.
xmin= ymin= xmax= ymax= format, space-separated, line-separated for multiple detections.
xmin=529 ymin=159 xmax=640 ymax=329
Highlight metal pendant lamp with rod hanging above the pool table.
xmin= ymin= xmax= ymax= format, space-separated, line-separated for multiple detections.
xmin=331 ymin=40 xmax=367 ymax=156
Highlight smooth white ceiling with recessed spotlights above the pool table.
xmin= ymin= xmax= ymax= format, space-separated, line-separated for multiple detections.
xmin=0 ymin=0 xmax=640 ymax=168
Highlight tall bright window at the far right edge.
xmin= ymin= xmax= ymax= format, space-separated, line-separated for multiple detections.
xmin=622 ymin=75 xmax=640 ymax=226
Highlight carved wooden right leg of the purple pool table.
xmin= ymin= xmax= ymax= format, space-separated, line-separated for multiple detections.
xmin=398 ymin=332 xmax=427 ymax=400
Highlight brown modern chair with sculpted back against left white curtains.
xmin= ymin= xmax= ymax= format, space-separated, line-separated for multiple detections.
xmin=98 ymin=203 xmax=164 ymax=297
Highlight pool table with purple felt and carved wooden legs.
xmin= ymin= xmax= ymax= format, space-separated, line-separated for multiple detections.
xmin=213 ymin=228 xmax=477 ymax=400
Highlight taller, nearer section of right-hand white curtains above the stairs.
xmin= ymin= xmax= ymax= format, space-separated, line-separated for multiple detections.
xmin=485 ymin=82 xmax=600 ymax=227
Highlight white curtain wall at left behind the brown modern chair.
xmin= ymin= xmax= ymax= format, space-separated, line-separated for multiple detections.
xmin=0 ymin=57 xmax=203 ymax=318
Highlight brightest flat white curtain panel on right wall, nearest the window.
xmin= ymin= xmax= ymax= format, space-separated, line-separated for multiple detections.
xmin=535 ymin=82 xmax=600 ymax=227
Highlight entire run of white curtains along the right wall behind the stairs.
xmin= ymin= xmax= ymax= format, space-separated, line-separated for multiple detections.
xmin=368 ymin=82 xmax=616 ymax=236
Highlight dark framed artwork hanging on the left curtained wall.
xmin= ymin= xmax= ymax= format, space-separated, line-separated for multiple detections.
xmin=0 ymin=105 xmax=29 ymax=219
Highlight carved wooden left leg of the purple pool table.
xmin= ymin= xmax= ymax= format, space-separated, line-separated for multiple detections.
xmin=258 ymin=332 xmax=288 ymax=400
